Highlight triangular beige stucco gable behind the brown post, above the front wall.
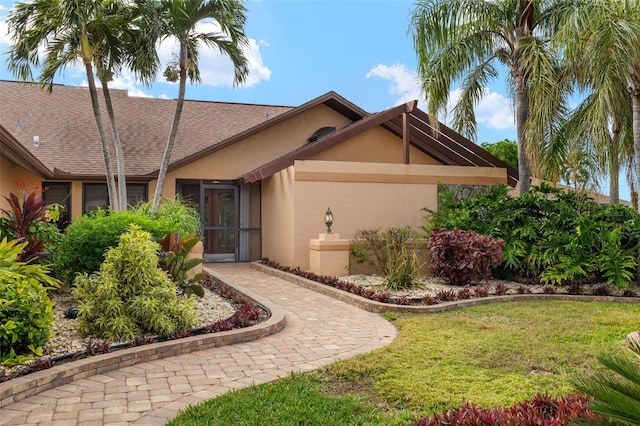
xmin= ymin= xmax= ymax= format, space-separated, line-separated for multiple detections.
xmin=312 ymin=127 xmax=440 ymax=164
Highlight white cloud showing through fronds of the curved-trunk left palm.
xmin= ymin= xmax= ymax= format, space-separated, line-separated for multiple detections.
xmin=158 ymin=22 xmax=271 ymax=87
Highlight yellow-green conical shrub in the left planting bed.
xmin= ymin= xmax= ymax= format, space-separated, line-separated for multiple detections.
xmin=75 ymin=225 xmax=196 ymax=342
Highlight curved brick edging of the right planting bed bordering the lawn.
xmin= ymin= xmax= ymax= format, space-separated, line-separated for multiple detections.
xmin=251 ymin=261 xmax=640 ymax=313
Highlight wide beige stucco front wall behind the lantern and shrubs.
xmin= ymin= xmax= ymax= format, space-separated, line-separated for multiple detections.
xmin=282 ymin=160 xmax=507 ymax=268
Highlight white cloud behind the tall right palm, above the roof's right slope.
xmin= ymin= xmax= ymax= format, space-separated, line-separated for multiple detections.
xmin=367 ymin=64 xmax=515 ymax=130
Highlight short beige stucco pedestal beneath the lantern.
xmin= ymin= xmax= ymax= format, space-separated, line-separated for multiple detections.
xmin=309 ymin=234 xmax=350 ymax=277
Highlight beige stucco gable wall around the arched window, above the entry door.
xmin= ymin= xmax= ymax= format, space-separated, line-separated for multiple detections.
xmin=158 ymin=105 xmax=350 ymax=197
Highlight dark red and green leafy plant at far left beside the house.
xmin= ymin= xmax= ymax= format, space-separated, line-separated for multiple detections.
xmin=0 ymin=179 xmax=60 ymax=261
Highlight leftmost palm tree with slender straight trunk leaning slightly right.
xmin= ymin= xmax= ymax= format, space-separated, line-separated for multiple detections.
xmin=7 ymin=0 xmax=124 ymax=211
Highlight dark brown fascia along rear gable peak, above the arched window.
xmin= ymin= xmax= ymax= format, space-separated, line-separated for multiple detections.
xmin=161 ymin=91 xmax=369 ymax=177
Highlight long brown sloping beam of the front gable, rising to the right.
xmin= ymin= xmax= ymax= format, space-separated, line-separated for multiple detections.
xmin=238 ymin=101 xmax=418 ymax=183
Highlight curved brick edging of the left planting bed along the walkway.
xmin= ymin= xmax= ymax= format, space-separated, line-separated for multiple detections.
xmin=0 ymin=266 xmax=286 ymax=408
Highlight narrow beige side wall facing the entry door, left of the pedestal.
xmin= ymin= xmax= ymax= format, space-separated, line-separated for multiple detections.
xmin=262 ymin=167 xmax=296 ymax=265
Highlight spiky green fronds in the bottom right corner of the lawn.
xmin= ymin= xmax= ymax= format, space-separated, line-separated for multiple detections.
xmin=574 ymin=341 xmax=640 ymax=425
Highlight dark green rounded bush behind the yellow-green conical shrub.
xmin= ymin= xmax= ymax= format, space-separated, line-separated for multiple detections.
xmin=53 ymin=210 xmax=180 ymax=283
